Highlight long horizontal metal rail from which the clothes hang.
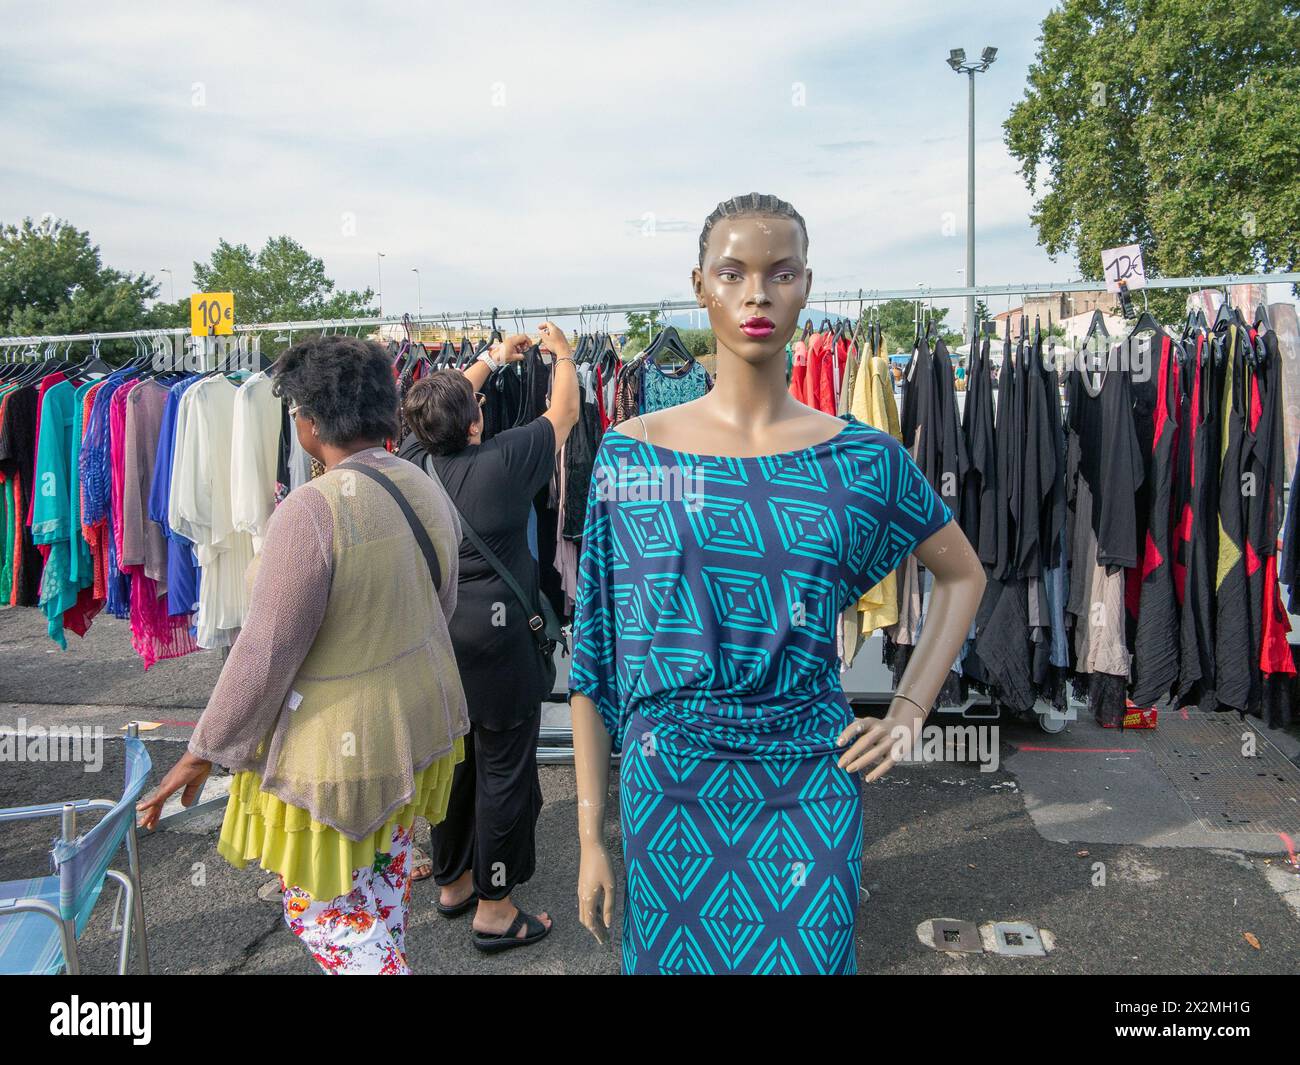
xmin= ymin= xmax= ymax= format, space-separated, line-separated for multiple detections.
xmin=0 ymin=272 xmax=1300 ymax=354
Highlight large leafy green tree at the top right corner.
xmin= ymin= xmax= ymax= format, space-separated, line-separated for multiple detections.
xmin=1004 ymin=0 xmax=1300 ymax=316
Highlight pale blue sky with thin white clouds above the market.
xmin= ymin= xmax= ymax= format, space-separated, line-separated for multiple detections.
xmin=0 ymin=0 xmax=1279 ymax=332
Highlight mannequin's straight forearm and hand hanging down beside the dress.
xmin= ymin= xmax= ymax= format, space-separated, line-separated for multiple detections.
xmin=569 ymin=692 xmax=614 ymax=943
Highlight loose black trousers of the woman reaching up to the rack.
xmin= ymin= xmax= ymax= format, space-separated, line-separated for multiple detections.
xmin=429 ymin=706 xmax=542 ymax=900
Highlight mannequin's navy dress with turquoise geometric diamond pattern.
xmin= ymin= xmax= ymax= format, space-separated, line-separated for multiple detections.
xmin=569 ymin=415 xmax=952 ymax=974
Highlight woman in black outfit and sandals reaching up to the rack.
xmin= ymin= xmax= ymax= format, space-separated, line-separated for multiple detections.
xmin=399 ymin=322 xmax=579 ymax=951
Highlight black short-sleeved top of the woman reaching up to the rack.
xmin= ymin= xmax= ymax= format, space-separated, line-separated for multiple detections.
xmin=398 ymin=417 xmax=555 ymax=730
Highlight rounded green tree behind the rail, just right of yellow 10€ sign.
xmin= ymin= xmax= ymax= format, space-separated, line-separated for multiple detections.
xmin=191 ymin=237 xmax=378 ymax=324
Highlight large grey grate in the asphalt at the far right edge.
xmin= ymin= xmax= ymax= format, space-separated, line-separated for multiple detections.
xmin=1135 ymin=711 xmax=1300 ymax=835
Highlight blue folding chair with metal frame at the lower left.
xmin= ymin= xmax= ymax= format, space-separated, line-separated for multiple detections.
xmin=0 ymin=722 xmax=153 ymax=975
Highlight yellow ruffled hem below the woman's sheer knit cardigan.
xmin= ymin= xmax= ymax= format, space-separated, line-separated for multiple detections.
xmin=217 ymin=737 xmax=465 ymax=899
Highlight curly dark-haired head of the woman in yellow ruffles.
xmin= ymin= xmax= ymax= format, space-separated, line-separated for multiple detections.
xmin=273 ymin=337 xmax=398 ymax=466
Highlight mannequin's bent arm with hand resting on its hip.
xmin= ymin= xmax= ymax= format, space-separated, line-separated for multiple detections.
xmin=840 ymin=521 xmax=985 ymax=782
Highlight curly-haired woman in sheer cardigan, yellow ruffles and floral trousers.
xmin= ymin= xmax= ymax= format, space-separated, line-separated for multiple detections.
xmin=139 ymin=337 xmax=469 ymax=974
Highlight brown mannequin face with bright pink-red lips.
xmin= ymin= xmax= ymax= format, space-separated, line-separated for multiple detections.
xmin=692 ymin=217 xmax=813 ymax=367
